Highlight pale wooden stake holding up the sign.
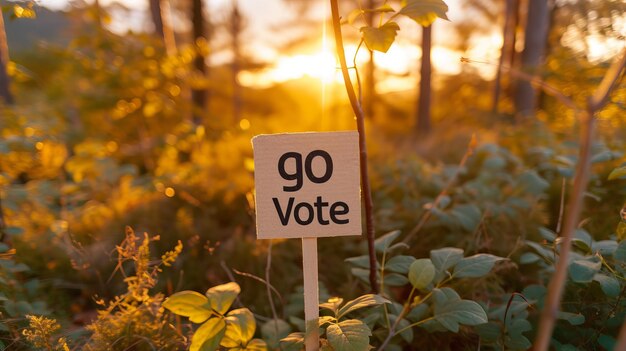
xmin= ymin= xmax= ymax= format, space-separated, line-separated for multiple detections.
xmin=302 ymin=238 xmax=320 ymax=351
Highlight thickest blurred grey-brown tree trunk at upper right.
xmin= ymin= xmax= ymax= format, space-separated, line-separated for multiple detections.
xmin=515 ymin=0 xmax=550 ymax=117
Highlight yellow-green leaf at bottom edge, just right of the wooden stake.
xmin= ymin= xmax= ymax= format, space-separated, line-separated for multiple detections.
xmin=326 ymin=319 xmax=372 ymax=351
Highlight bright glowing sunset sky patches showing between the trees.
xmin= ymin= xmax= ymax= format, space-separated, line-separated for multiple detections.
xmin=37 ymin=0 xmax=619 ymax=92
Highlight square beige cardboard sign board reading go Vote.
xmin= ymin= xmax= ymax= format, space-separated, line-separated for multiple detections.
xmin=252 ymin=131 xmax=361 ymax=239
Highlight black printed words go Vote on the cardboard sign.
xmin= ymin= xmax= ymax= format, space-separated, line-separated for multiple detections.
xmin=272 ymin=150 xmax=350 ymax=226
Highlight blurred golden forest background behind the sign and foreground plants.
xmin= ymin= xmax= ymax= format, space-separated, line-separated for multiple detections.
xmin=0 ymin=0 xmax=626 ymax=350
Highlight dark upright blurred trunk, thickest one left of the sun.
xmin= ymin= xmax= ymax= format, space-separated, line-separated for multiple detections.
xmin=191 ymin=0 xmax=208 ymax=126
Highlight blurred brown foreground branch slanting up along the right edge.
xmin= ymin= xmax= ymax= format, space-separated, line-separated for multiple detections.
xmin=533 ymin=48 xmax=626 ymax=351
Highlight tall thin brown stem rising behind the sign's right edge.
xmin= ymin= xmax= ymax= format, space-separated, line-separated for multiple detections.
xmin=330 ymin=0 xmax=379 ymax=294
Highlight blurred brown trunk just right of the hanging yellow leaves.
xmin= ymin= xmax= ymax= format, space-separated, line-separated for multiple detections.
xmin=417 ymin=24 xmax=433 ymax=135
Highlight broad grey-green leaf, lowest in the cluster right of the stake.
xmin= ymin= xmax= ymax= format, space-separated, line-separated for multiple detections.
xmin=435 ymin=300 xmax=487 ymax=333
